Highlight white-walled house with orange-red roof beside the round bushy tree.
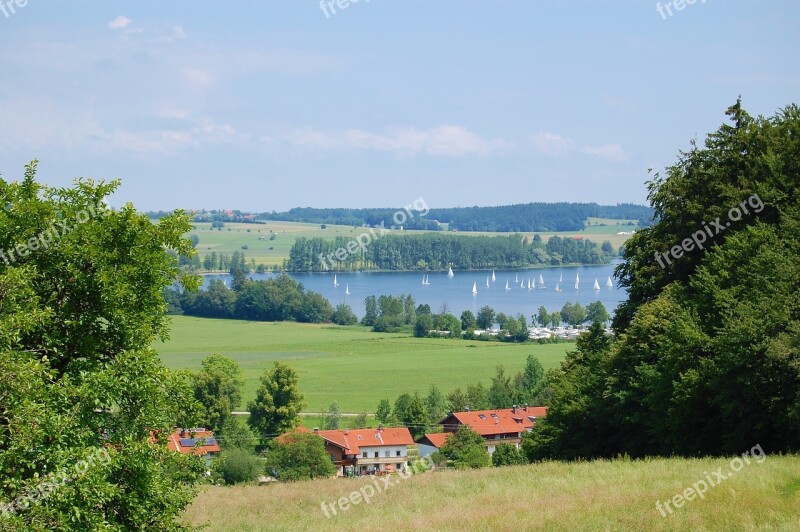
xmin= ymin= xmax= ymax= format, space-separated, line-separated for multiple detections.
xmin=314 ymin=425 xmax=414 ymax=476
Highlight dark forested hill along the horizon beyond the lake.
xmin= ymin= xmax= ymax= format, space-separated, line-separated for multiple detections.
xmin=258 ymin=203 xmax=653 ymax=233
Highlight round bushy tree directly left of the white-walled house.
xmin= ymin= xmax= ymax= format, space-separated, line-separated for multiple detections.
xmin=266 ymin=432 xmax=336 ymax=481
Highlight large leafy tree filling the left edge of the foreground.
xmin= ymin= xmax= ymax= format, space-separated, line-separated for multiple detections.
xmin=0 ymin=161 xmax=203 ymax=530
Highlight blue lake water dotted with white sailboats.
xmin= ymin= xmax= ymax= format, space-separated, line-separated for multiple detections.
xmin=200 ymin=263 xmax=627 ymax=321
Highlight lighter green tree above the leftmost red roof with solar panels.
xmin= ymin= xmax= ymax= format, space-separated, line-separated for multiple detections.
xmin=192 ymin=354 xmax=245 ymax=434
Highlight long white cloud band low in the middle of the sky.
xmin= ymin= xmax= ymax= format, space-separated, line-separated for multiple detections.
xmin=263 ymin=124 xmax=511 ymax=157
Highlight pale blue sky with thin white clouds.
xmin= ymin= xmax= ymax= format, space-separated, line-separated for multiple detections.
xmin=0 ymin=0 xmax=800 ymax=212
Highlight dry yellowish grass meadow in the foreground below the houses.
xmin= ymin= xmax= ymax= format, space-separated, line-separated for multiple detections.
xmin=186 ymin=456 xmax=800 ymax=531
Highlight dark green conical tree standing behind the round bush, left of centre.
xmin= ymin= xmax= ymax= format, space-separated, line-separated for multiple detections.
xmin=247 ymin=360 xmax=305 ymax=444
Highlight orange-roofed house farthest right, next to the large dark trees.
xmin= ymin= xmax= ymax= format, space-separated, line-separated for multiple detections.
xmin=439 ymin=405 xmax=547 ymax=454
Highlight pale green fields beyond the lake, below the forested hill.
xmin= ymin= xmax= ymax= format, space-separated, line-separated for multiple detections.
xmin=189 ymin=218 xmax=636 ymax=266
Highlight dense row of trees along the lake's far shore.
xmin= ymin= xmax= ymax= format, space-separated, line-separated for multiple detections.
xmin=286 ymin=233 xmax=616 ymax=272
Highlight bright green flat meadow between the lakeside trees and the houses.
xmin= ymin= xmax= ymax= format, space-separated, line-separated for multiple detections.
xmin=154 ymin=316 xmax=573 ymax=412
